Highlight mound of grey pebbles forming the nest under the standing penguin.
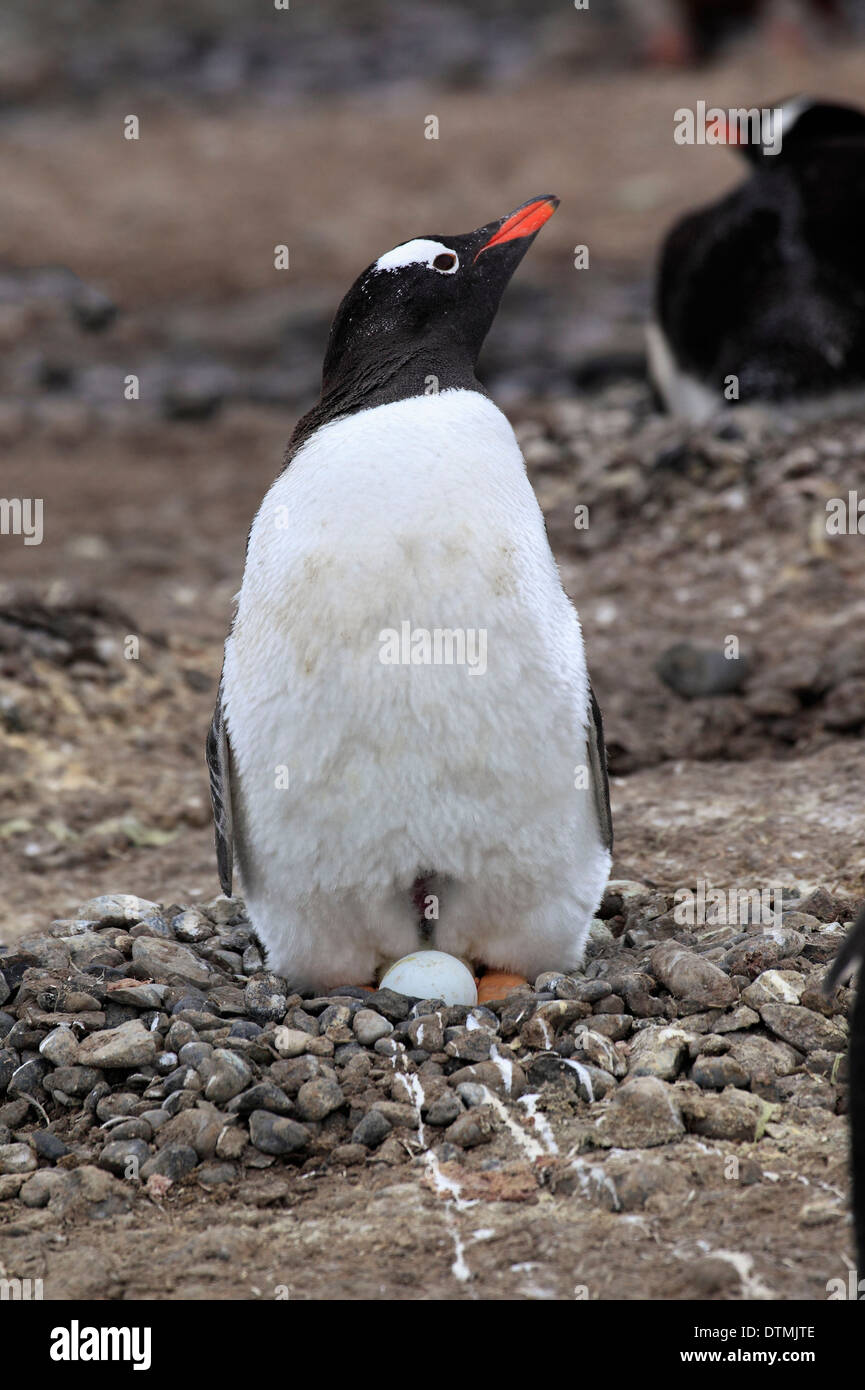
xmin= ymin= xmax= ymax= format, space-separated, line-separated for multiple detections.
xmin=0 ymin=880 xmax=855 ymax=1215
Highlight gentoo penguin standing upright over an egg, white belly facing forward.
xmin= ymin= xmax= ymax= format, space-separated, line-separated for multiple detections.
xmin=207 ymin=196 xmax=612 ymax=992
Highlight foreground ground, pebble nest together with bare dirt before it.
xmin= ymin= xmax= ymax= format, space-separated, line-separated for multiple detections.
xmin=0 ymin=880 xmax=850 ymax=1298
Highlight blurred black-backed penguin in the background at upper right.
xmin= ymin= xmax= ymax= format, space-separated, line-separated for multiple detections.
xmin=648 ymin=97 xmax=865 ymax=423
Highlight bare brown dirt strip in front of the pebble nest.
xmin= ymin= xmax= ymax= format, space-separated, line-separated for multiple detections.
xmin=0 ymin=1116 xmax=851 ymax=1301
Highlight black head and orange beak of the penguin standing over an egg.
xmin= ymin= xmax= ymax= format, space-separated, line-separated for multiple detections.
xmin=323 ymin=193 xmax=559 ymax=391
